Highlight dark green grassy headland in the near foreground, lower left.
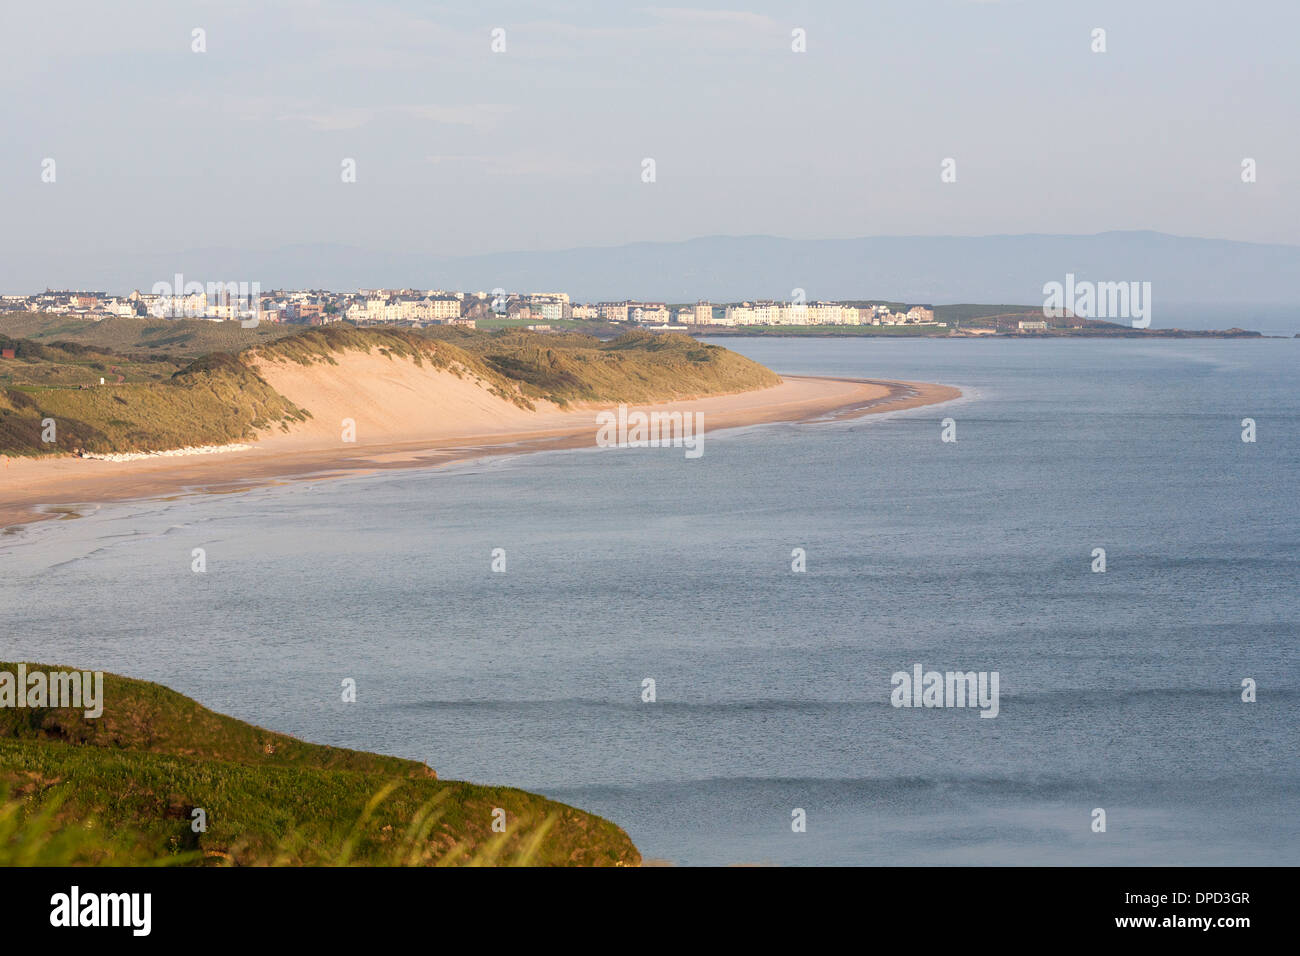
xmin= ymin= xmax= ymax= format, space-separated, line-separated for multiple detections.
xmin=0 ymin=662 xmax=641 ymax=866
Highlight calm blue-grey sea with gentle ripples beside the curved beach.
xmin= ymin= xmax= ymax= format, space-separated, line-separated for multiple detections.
xmin=0 ymin=338 xmax=1300 ymax=865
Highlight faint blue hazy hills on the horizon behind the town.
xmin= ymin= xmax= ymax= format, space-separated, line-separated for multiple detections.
xmin=0 ymin=232 xmax=1300 ymax=330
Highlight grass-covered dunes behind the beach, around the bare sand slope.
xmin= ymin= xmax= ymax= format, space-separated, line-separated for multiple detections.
xmin=0 ymin=320 xmax=780 ymax=455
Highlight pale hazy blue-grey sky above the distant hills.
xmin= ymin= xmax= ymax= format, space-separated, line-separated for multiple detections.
xmin=0 ymin=0 xmax=1300 ymax=265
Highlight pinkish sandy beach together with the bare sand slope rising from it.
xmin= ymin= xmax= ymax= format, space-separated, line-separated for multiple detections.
xmin=0 ymin=374 xmax=961 ymax=528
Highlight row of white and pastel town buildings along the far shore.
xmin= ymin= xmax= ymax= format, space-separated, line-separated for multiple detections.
xmin=0 ymin=287 xmax=946 ymax=332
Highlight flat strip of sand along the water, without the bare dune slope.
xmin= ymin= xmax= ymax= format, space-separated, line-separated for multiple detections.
xmin=0 ymin=375 xmax=962 ymax=531
